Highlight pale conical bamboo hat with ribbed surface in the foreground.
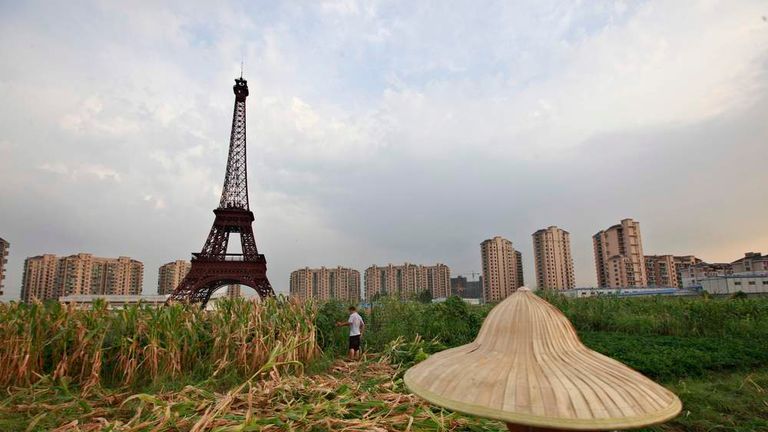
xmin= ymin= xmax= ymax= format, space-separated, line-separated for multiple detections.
xmin=405 ymin=288 xmax=682 ymax=430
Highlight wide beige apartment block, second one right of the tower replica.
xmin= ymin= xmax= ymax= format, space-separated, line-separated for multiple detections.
xmin=365 ymin=263 xmax=451 ymax=300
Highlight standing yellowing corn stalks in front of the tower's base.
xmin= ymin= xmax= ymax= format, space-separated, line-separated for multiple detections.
xmin=0 ymin=299 xmax=319 ymax=394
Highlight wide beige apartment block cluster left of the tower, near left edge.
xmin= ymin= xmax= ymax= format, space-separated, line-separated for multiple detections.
xmin=22 ymin=253 xmax=144 ymax=301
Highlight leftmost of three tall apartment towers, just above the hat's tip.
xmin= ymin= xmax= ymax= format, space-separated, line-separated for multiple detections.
xmin=480 ymin=236 xmax=524 ymax=302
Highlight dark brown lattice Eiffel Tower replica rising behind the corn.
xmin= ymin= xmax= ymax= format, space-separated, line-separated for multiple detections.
xmin=168 ymin=74 xmax=275 ymax=307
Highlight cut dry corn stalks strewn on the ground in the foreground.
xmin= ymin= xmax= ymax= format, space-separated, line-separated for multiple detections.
xmin=0 ymin=355 xmax=504 ymax=432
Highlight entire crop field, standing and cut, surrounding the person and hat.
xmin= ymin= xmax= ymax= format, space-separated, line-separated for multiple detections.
xmin=0 ymin=294 xmax=768 ymax=431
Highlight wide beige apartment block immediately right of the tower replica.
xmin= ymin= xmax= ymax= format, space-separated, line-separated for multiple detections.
xmin=289 ymin=267 xmax=360 ymax=303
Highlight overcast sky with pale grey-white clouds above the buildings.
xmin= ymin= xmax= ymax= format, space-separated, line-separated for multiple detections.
xmin=0 ymin=0 xmax=768 ymax=299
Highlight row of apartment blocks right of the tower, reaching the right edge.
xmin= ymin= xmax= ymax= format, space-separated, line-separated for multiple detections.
xmin=291 ymin=219 xmax=768 ymax=302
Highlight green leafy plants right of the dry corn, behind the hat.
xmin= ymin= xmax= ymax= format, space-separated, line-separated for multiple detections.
xmin=318 ymin=292 xmax=768 ymax=380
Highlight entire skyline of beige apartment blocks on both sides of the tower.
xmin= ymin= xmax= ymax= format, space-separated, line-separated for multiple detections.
xmin=12 ymin=219 xmax=768 ymax=302
